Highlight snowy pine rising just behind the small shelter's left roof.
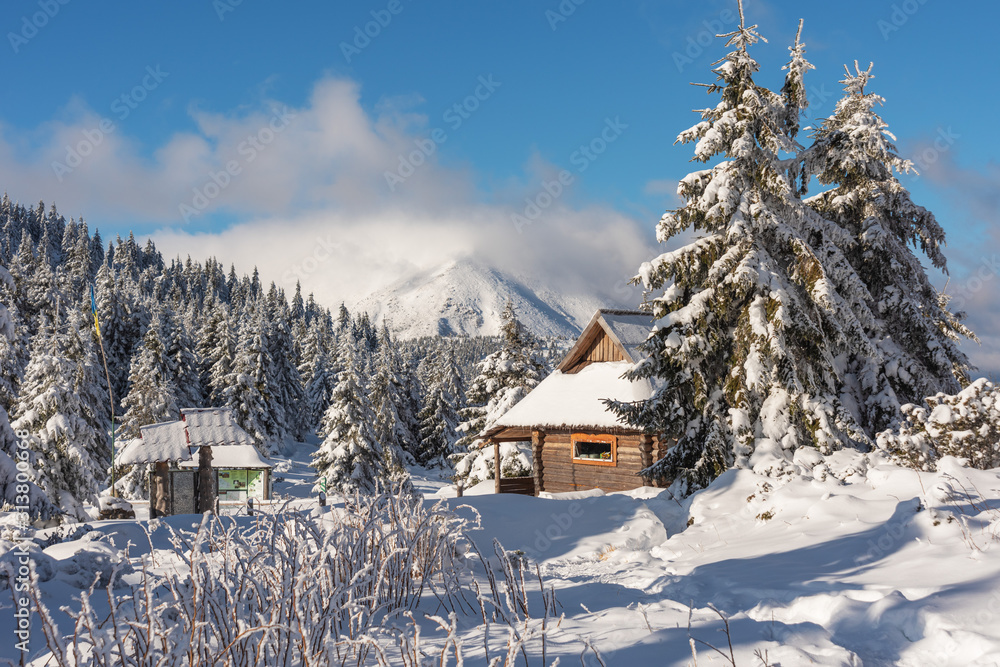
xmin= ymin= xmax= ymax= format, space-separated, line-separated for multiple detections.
xmin=116 ymin=311 xmax=180 ymax=440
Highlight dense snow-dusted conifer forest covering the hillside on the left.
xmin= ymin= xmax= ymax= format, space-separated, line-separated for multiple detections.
xmin=0 ymin=201 xmax=565 ymax=518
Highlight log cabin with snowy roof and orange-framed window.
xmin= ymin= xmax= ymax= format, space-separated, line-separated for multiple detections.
xmin=484 ymin=310 xmax=665 ymax=495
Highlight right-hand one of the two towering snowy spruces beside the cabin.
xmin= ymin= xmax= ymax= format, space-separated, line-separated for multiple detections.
xmin=804 ymin=61 xmax=975 ymax=431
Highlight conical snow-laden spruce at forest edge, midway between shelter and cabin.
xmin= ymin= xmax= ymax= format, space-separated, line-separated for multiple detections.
xmin=310 ymin=335 xmax=389 ymax=494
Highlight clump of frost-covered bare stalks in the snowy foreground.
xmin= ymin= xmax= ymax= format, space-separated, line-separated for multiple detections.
xmin=31 ymin=489 xmax=576 ymax=667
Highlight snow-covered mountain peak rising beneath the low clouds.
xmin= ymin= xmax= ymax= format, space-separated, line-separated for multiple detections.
xmin=349 ymin=259 xmax=620 ymax=338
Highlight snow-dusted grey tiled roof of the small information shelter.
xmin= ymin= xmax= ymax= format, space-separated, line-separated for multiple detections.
xmin=116 ymin=408 xmax=271 ymax=468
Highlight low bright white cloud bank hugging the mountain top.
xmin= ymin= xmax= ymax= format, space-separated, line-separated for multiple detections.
xmin=153 ymin=205 xmax=651 ymax=314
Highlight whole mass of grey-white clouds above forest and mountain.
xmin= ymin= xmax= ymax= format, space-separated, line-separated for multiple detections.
xmin=0 ymin=78 xmax=653 ymax=314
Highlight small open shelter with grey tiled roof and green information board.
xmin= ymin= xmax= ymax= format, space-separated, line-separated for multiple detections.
xmin=115 ymin=408 xmax=271 ymax=518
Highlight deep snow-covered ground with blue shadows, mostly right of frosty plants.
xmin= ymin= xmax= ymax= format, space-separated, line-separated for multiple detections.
xmin=0 ymin=444 xmax=1000 ymax=667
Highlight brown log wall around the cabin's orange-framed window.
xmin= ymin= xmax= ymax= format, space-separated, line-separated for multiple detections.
xmin=541 ymin=431 xmax=643 ymax=493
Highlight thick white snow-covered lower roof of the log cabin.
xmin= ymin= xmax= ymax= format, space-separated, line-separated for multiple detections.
xmin=489 ymin=361 xmax=653 ymax=435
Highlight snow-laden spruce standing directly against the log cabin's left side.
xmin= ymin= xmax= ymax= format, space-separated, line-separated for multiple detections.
xmin=452 ymin=301 xmax=545 ymax=486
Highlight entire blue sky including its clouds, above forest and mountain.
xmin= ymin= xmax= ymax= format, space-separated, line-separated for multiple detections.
xmin=0 ymin=0 xmax=1000 ymax=372
